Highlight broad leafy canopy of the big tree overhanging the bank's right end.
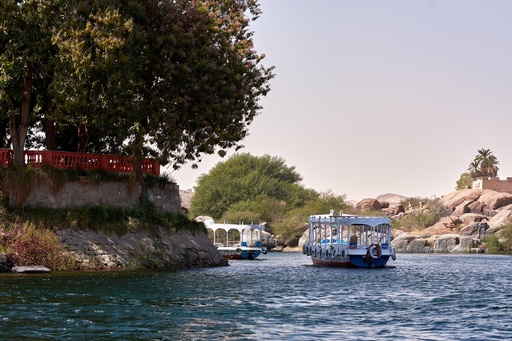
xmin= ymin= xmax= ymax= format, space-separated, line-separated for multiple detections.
xmin=53 ymin=0 xmax=272 ymax=179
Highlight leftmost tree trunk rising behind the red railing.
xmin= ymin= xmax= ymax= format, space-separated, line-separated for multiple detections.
xmin=9 ymin=64 xmax=32 ymax=165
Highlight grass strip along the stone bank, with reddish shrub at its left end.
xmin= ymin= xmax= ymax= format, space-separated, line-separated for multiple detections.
xmin=0 ymin=204 xmax=206 ymax=271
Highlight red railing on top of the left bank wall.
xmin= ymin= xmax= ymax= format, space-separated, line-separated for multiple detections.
xmin=0 ymin=148 xmax=160 ymax=175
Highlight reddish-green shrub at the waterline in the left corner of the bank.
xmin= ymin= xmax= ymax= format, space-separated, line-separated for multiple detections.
xmin=0 ymin=221 xmax=76 ymax=271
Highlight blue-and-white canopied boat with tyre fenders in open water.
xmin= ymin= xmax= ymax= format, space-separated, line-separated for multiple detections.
xmin=302 ymin=211 xmax=396 ymax=268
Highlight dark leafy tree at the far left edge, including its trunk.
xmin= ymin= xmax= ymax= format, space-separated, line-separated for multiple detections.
xmin=0 ymin=0 xmax=59 ymax=164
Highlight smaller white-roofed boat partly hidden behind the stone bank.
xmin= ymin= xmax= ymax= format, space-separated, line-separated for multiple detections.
xmin=204 ymin=220 xmax=267 ymax=259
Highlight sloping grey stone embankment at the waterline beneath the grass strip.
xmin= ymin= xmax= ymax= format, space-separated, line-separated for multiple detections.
xmin=0 ymin=228 xmax=228 ymax=271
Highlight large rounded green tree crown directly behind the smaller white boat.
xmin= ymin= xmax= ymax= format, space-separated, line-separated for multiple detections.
xmin=190 ymin=153 xmax=318 ymax=222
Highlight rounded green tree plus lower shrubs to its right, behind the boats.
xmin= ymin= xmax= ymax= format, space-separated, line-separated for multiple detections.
xmin=189 ymin=153 xmax=351 ymax=246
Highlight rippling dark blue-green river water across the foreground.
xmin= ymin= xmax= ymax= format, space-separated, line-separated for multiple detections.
xmin=0 ymin=253 xmax=512 ymax=341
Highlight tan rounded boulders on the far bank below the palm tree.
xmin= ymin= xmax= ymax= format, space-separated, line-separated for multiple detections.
xmin=299 ymin=189 xmax=512 ymax=253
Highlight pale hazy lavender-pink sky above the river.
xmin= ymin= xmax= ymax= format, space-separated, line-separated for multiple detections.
xmin=169 ymin=0 xmax=512 ymax=201
